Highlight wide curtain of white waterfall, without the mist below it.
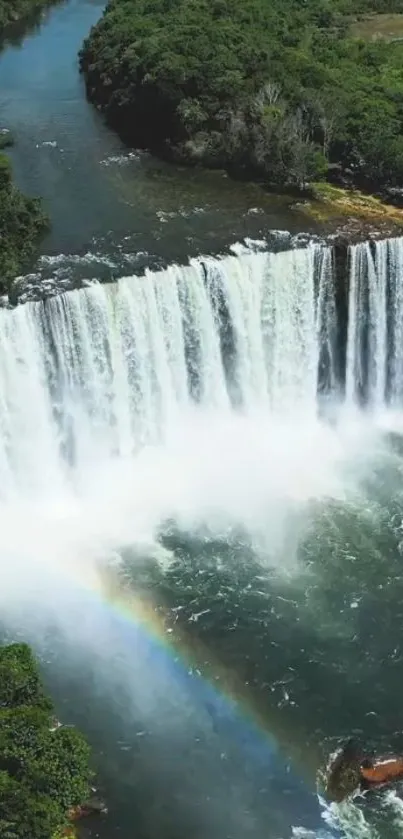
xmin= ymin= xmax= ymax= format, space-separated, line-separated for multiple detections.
xmin=0 ymin=233 xmax=403 ymax=498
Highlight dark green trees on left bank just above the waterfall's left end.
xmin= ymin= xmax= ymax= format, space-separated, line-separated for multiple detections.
xmin=0 ymin=154 xmax=48 ymax=296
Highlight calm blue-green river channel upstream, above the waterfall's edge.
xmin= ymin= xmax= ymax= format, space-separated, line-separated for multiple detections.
xmin=0 ymin=0 xmax=312 ymax=278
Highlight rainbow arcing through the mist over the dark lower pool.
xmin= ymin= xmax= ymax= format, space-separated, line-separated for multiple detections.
xmin=69 ymin=571 xmax=322 ymax=793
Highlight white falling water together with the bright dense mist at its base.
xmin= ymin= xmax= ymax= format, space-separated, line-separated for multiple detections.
xmin=0 ymin=241 xmax=403 ymax=612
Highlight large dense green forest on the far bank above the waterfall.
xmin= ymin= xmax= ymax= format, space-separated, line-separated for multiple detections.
xmin=80 ymin=0 xmax=403 ymax=189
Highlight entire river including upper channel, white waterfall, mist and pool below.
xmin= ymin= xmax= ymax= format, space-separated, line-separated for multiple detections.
xmin=0 ymin=0 xmax=403 ymax=839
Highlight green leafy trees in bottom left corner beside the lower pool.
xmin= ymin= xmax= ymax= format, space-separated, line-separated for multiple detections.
xmin=0 ymin=644 xmax=91 ymax=839
